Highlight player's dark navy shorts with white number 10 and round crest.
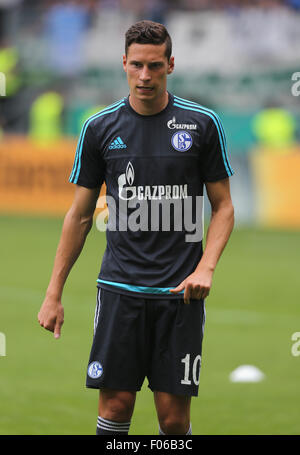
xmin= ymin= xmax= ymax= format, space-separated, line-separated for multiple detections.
xmin=86 ymin=288 xmax=205 ymax=396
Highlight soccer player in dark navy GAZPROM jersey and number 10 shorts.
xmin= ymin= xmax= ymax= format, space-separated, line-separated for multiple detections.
xmin=38 ymin=21 xmax=234 ymax=435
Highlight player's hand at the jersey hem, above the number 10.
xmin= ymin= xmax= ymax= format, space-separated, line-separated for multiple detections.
xmin=170 ymin=270 xmax=213 ymax=304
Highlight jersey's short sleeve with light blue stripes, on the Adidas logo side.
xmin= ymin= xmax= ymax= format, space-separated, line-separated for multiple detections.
xmin=69 ymin=123 xmax=105 ymax=188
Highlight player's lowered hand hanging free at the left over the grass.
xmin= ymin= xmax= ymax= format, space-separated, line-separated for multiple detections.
xmin=38 ymin=296 xmax=64 ymax=338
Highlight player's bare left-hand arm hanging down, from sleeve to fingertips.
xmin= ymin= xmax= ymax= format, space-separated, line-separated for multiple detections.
xmin=38 ymin=185 xmax=100 ymax=338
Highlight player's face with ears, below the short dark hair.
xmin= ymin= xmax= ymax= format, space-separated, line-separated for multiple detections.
xmin=123 ymin=43 xmax=174 ymax=102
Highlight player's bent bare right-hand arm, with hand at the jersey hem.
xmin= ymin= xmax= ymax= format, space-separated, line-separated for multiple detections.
xmin=171 ymin=178 xmax=234 ymax=303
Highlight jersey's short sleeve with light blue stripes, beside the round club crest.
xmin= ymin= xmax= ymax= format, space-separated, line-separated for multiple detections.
xmin=201 ymin=115 xmax=234 ymax=182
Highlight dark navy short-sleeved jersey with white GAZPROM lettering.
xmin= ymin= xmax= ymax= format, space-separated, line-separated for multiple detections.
xmin=70 ymin=93 xmax=233 ymax=298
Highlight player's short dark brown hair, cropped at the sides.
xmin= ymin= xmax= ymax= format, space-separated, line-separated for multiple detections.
xmin=125 ymin=21 xmax=172 ymax=60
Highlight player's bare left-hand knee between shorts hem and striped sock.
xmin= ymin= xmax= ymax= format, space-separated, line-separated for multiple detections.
xmin=101 ymin=394 xmax=134 ymax=422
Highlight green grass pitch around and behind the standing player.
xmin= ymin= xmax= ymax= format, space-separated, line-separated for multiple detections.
xmin=0 ymin=216 xmax=300 ymax=435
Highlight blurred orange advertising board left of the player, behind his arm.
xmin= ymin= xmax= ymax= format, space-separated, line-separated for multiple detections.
xmin=0 ymin=137 xmax=104 ymax=215
